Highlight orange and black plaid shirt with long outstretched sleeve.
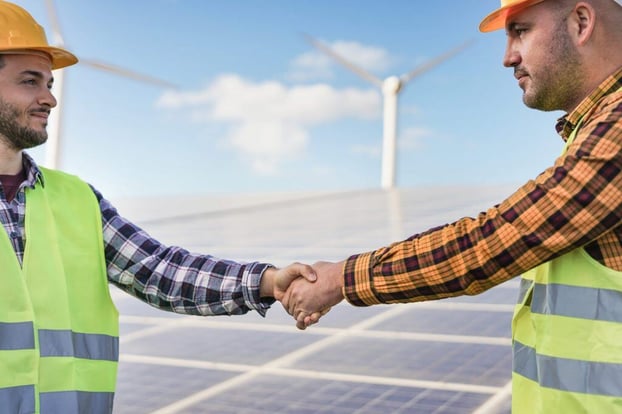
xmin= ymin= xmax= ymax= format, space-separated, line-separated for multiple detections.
xmin=344 ymin=68 xmax=622 ymax=306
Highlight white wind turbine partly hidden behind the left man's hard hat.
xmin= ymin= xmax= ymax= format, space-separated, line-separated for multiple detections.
xmin=45 ymin=0 xmax=177 ymax=169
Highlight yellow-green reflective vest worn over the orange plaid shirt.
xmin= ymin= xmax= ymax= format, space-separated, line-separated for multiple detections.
xmin=512 ymin=115 xmax=622 ymax=414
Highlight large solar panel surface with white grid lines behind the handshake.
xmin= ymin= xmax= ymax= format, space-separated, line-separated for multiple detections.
xmin=111 ymin=188 xmax=518 ymax=414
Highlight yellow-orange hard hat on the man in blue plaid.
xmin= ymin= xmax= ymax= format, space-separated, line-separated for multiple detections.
xmin=0 ymin=1 xmax=78 ymax=69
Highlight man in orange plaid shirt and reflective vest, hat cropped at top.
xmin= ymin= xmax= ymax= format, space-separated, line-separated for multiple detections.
xmin=284 ymin=0 xmax=622 ymax=414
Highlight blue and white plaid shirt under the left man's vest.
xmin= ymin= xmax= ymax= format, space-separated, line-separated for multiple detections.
xmin=0 ymin=153 xmax=274 ymax=315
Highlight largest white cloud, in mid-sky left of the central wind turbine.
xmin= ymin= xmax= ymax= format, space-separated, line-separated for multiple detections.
xmin=157 ymin=74 xmax=381 ymax=174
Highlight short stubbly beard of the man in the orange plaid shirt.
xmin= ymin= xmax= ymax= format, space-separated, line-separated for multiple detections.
xmin=523 ymin=20 xmax=583 ymax=111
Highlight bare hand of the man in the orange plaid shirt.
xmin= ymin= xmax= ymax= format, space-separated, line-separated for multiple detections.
xmin=281 ymin=262 xmax=344 ymax=329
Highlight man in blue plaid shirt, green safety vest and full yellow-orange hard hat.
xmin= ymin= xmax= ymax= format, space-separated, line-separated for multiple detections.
xmin=0 ymin=1 xmax=324 ymax=414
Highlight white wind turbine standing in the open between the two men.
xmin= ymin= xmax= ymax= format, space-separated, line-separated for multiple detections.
xmin=305 ymin=35 xmax=472 ymax=189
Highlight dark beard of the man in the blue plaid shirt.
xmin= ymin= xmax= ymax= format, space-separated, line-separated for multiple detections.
xmin=0 ymin=99 xmax=48 ymax=151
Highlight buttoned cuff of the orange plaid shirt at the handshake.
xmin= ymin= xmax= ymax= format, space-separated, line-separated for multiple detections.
xmin=343 ymin=252 xmax=382 ymax=306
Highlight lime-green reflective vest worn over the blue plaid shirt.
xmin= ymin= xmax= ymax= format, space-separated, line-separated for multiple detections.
xmin=0 ymin=169 xmax=119 ymax=414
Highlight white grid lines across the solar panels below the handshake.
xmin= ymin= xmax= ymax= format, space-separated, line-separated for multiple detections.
xmin=115 ymin=288 xmax=509 ymax=413
